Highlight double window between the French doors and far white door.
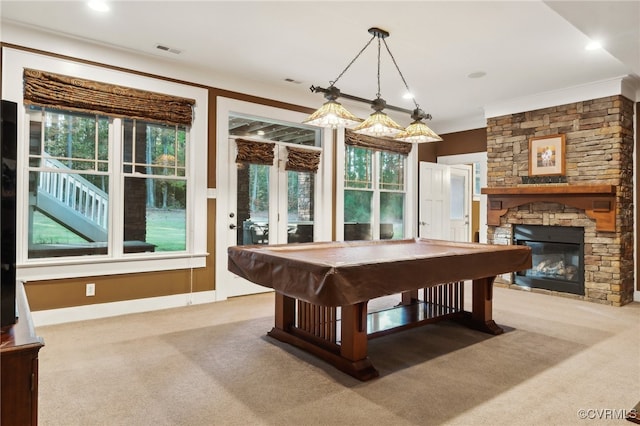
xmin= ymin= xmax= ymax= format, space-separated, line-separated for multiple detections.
xmin=344 ymin=145 xmax=407 ymax=240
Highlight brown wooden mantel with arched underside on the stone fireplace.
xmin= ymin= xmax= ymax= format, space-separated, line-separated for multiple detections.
xmin=480 ymin=185 xmax=616 ymax=232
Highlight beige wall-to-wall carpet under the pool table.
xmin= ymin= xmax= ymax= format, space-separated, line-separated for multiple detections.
xmin=37 ymin=282 xmax=640 ymax=426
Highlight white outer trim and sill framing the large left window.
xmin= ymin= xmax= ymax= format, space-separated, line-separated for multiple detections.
xmin=2 ymin=48 xmax=208 ymax=281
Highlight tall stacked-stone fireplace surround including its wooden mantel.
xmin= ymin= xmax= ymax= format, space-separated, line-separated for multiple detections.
xmin=483 ymin=95 xmax=634 ymax=306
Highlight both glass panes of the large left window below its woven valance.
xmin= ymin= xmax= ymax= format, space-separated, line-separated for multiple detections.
xmin=27 ymin=106 xmax=189 ymax=259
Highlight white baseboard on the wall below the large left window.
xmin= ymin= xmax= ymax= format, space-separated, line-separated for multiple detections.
xmin=31 ymin=290 xmax=216 ymax=327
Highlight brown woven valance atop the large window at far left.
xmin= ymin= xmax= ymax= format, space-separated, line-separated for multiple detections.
xmin=23 ymin=68 xmax=196 ymax=126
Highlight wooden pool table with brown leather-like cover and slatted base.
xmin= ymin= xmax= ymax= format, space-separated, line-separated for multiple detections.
xmin=228 ymin=238 xmax=531 ymax=380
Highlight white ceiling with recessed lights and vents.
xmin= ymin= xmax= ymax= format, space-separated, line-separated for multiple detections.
xmin=0 ymin=0 xmax=640 ymax=133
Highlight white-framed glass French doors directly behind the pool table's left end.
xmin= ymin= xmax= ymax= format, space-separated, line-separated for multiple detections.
xmin=215 ymin=98 xmax=330 ymax=300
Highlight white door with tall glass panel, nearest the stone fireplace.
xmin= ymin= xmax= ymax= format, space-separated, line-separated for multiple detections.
xmin=450 ymin=165 xmax=473 ymax=241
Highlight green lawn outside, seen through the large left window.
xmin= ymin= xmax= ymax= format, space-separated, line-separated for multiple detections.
xmin=33 ymin=209 xmax=186 ymax=251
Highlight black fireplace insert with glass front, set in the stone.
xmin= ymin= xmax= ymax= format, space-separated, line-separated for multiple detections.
xmin=514 ymin=225 xmax=584 ymax=295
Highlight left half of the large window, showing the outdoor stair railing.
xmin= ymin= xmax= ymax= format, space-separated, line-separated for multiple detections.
xmin=28 ymin=106 xmax=110 ymax=259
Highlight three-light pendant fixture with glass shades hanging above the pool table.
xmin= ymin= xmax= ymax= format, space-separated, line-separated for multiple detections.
xmin=304 ymin=27 xmax=442 ymax=143
